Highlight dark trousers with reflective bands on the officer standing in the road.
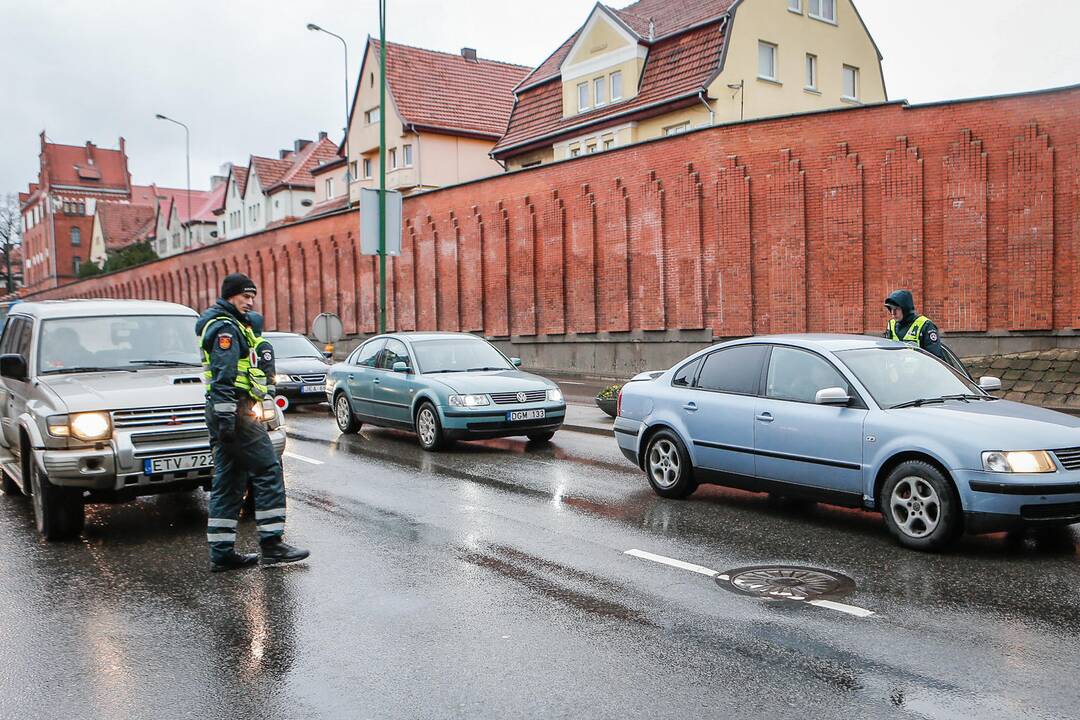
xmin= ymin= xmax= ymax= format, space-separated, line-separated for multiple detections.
xmin=206 ymin=399 xmax=285 ymax=560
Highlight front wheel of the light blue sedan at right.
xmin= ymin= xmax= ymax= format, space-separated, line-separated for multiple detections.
xmin=878 ymin=460 xmax=961 ymax=551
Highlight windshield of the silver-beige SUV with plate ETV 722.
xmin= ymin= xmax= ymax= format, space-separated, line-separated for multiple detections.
xmin=38 ymin=315 xmax=201 ymax=375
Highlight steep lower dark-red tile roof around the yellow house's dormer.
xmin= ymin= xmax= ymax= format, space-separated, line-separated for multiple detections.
xmin=494 ymin=21 xmax=724 ymax=157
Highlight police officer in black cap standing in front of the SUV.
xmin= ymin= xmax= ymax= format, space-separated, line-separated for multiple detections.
xmin=195 ymin=273 xmax=308 ymax=572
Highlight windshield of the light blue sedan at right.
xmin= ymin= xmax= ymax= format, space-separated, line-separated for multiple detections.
xmin=836 ymin=348 xmax=986 ymax=408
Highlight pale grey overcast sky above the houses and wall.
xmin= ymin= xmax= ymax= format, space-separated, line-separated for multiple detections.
xmin=0 ymin=0 xmax=1080 ymax=193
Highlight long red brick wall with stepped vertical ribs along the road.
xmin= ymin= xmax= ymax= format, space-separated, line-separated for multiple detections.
xmin=23 ymin=87 xmax=1080 ymax=337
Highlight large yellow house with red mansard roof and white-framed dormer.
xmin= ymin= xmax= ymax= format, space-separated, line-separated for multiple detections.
xmin=492 ymin=0 xmax=887 ymax=169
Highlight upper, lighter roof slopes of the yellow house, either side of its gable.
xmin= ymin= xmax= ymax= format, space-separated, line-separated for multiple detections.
xmin=519 ymin=0 xmax=737 ymax=89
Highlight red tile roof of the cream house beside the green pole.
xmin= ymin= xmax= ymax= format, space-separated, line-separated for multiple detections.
xmin=367 ymin=39 xmax=529 ymax=138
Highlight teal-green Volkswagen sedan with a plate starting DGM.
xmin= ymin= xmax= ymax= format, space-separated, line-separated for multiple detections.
xmin=326 ymin=332 xmax=566 ymax=450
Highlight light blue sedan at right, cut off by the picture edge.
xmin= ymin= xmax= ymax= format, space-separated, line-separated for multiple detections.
xmin=615 ymin=335 xmax=1080 ymax=549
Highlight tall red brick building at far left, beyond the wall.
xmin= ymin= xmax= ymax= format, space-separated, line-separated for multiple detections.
xmin=21 ymin=131 xmax=132 ymax=291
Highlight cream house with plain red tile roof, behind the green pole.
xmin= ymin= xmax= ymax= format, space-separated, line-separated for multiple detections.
xmin=348 ymin=38 xmax=529 ymax=202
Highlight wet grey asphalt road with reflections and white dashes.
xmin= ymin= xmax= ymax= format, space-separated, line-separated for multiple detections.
xmin=0 ymin=411 xmax=1080 ymax=719
